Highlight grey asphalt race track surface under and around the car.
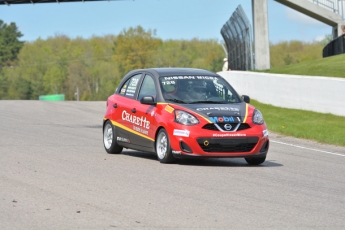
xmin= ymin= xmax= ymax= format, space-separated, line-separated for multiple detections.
xmin=0 ymin=101 xmax=345 ymax=230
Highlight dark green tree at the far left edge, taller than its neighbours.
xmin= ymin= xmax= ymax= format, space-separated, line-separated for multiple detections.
xmin=0 ymin=20 xmax=24 ymax=68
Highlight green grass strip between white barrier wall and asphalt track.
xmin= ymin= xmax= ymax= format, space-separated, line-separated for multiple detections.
xmin=250 ymin=100 xmax=345 ymax=146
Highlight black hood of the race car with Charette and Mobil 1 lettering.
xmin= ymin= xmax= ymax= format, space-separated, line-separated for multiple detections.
xmin=177 ymin=102 xmax=247 ymax=122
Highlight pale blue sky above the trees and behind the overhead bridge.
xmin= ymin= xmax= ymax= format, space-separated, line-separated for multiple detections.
xmin=0 ymin=0 xmax=332 ymax=43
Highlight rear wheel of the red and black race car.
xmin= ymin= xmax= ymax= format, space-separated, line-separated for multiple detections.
xmin=103 ymin=120 xmax=123 ymax=154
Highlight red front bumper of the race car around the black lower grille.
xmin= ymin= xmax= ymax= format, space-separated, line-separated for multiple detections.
xmin=170 ymin=126 xmax=269 ymax=158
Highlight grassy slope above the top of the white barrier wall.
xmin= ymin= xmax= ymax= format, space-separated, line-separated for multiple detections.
xmin=259 ymin=54 xmax=345 ymax=78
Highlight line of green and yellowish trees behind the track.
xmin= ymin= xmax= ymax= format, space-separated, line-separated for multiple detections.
xmin=0 ymin=20 xmax=325 ymax=100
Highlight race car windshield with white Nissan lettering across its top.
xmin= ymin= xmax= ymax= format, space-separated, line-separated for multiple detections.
xmin=159 ymin=76 xmax=240 ymax=104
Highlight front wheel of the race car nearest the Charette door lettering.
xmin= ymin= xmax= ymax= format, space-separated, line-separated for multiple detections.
xmin=156 ymin=129 xmax=176 ymax=164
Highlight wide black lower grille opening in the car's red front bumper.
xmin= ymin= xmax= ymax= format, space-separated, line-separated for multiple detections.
xmin=197 ymin=137 xmax=259 ymax=152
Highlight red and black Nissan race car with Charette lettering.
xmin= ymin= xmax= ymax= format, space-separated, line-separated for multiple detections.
xmin=103 ymin=68 xmax=269 ymax=165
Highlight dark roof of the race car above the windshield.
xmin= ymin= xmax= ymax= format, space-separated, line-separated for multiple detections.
xmin=129 ymin=68 xmax=218 ymax=76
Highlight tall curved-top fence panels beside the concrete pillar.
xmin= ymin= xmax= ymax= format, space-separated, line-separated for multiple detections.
xmin=220 ymin=5 xmax=254 ymax=70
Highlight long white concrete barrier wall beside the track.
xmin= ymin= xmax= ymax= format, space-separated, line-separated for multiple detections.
xmin=218 ymin=71 xmax=345 ymax=116
